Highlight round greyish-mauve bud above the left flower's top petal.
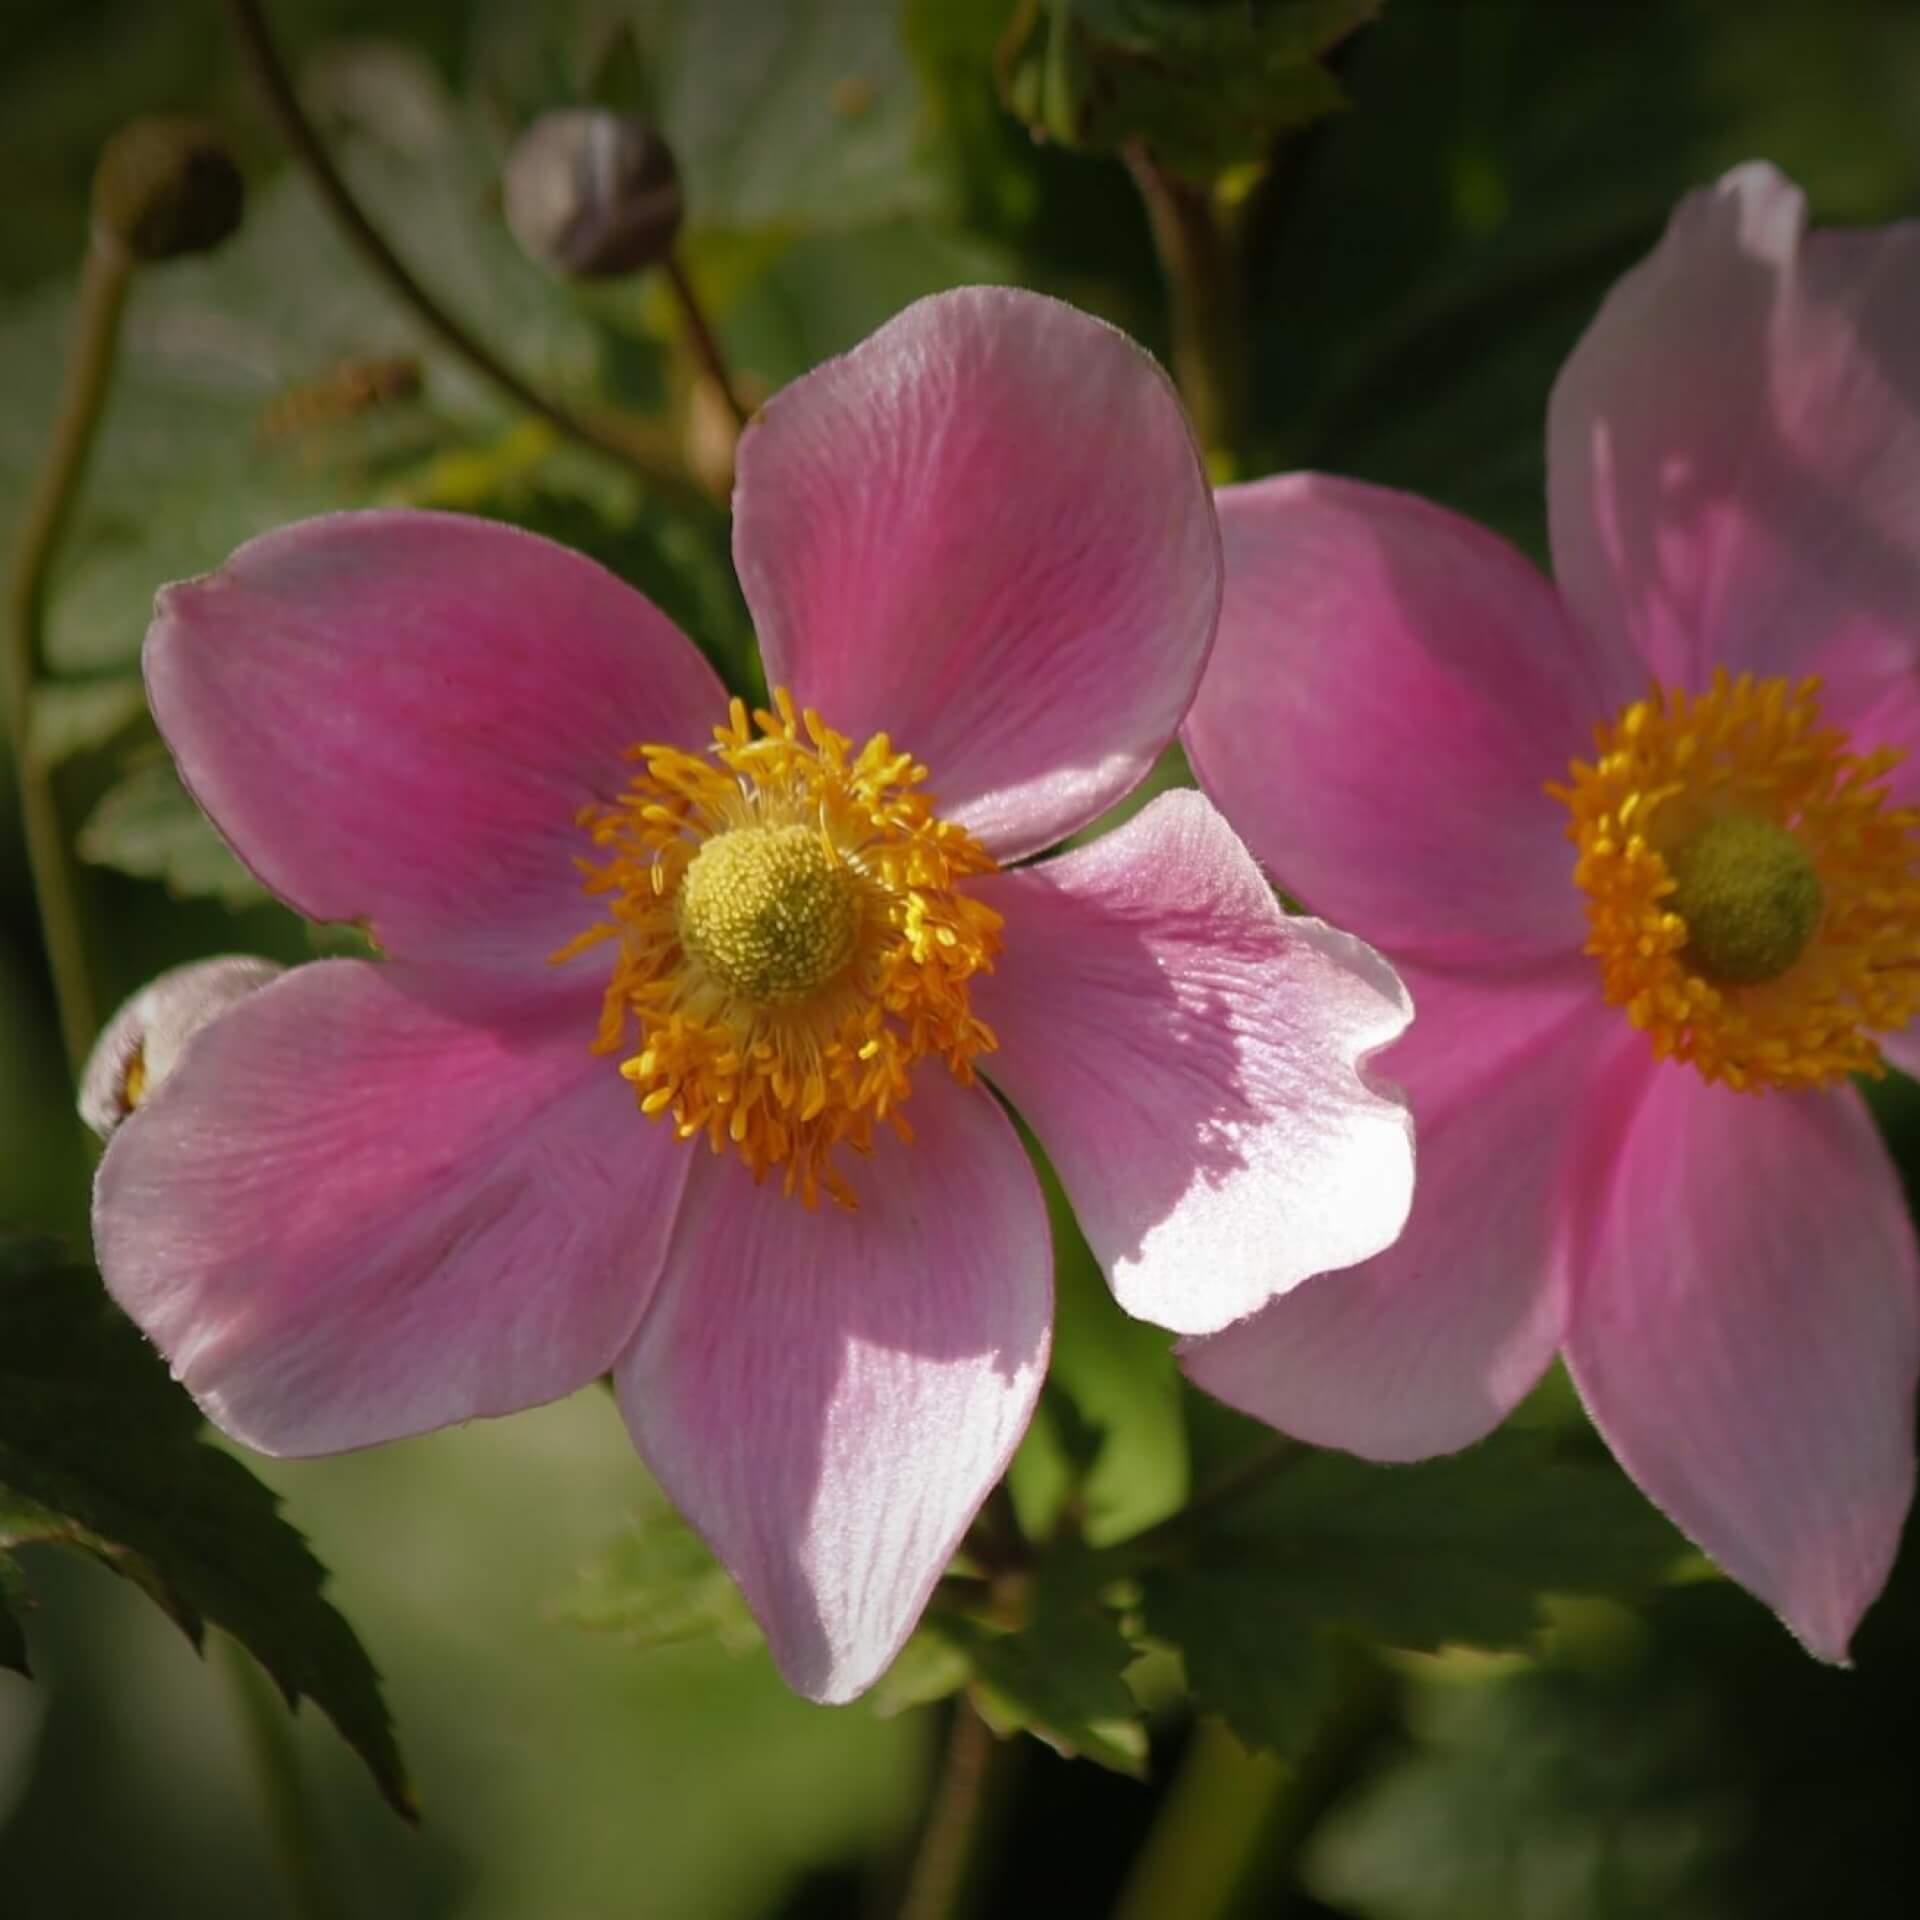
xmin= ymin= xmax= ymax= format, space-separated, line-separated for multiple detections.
xmin=503 ymin=108 xmax=682 ymax=280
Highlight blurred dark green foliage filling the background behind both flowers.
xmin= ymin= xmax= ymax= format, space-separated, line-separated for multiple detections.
xmin=0 ymin=0 xmax=1920 ymax=1920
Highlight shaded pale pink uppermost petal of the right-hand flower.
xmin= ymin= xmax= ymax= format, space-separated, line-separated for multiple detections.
xmin=1548 ymin=165 xmax=1920 ymax=707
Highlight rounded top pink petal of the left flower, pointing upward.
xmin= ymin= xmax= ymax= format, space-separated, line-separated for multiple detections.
xmin=733 ymin=286 xmax=1219 ymax=858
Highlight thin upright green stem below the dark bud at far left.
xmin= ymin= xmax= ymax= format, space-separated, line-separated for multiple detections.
xmin=6 ymin=227 xmax=134 ymax=1073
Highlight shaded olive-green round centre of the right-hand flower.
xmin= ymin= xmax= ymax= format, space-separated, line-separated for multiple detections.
xmin=1665 ymin=814 xmax=1826 ymax=987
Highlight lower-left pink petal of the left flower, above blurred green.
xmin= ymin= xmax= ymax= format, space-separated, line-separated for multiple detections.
xmin=94 ymin=960 xmax=693 ymax=1453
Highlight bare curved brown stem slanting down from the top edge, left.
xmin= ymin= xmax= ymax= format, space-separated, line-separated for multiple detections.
xmin=228 ymin=0 xmax=699 ymax=499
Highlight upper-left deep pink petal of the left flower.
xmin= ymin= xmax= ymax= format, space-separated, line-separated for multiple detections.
xmin=146 ymin=513 xmax=726 ymax=1021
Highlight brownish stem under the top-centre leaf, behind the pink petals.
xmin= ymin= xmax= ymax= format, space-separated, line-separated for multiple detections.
xmin=1125 ymin=140 xmax=1252 ymax=478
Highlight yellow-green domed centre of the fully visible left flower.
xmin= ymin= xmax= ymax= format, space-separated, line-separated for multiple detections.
xmin=676 ymin=826 xmax=864 ymax=1008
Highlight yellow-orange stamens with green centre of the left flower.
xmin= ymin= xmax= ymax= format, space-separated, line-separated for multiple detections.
xmin=553 ymin=689 xmax=1000 ymax=1208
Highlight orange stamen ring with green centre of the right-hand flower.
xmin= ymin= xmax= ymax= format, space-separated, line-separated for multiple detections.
xmin=1548 ymin=672 xmax=1920 ymax=1091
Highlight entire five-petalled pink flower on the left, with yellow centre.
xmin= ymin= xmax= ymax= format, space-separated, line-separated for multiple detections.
xmin=96 ymin=290 xmax=1411 ymax=1699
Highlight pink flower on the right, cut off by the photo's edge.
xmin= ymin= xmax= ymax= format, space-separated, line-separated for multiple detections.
xmin=1187 ymin=167 xmax=1920 ymax=1659
